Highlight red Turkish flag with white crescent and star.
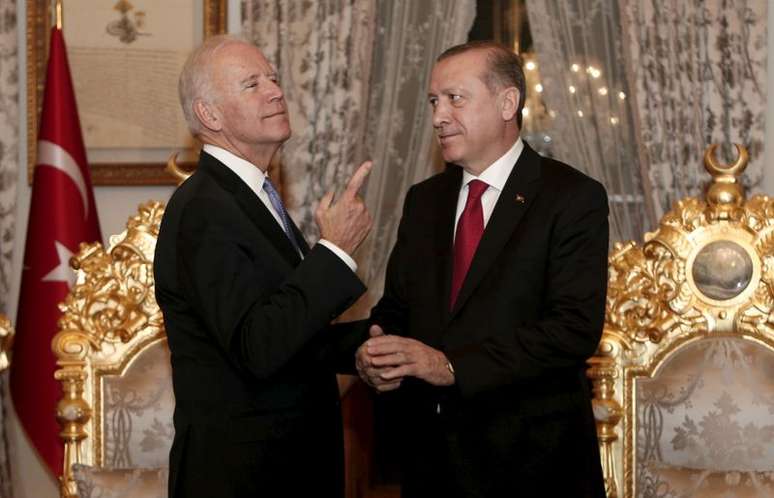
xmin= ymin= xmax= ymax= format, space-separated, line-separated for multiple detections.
xmin=11 ymin=28 xmax=101 ymax=475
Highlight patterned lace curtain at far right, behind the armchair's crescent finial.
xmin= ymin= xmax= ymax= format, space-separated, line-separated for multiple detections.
xmin=622 ymin=0 xmax=767 ymax=215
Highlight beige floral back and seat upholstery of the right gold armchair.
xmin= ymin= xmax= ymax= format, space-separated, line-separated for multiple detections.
xmin=635 ymin=338 xmax=774 ymax=497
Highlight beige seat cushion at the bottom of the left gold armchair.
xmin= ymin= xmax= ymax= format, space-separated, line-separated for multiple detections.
xmin=73 ymin=463 xmax=169 ymax=498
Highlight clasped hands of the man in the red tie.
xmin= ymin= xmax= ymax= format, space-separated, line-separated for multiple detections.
xmin=355 ymin=325 xmax=454 ymax=392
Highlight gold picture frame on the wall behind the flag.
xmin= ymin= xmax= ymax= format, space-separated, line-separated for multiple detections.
xmin=27 ymin=0 xmax=226 ymax=185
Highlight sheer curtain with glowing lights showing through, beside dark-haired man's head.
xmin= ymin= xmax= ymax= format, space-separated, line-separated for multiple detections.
xmin=527 ymin=0 xmax=657 ymax=242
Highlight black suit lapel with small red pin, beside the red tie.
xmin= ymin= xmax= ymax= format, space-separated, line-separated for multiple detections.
xmin=448 ymin=143 xmax=540 ymax=318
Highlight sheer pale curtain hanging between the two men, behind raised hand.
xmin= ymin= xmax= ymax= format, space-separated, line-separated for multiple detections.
xmin=360 ymin=0 xmax=476 ymax=304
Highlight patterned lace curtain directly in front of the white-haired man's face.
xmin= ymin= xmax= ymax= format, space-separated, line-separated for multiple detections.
xmin=241 ymin=0 xmax=376 ymax=241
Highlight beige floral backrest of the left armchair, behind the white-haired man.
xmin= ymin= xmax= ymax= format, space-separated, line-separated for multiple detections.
xmin=102 ymin=341 xmax=175 ymax=468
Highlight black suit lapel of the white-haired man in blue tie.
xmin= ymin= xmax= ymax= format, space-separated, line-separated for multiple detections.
xmin=198 ymin=151 xmax=308 ymax=266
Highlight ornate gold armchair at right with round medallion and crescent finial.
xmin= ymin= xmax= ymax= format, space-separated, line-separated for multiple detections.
xmin=588 ymin=145 xmax=774 ymax=498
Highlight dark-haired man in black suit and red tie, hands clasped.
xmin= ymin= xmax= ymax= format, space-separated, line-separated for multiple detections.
xmin=357 ymin=43 xmax=608 ymax=498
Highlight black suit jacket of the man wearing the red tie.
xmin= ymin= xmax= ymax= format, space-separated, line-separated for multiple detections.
xmin=372 ymin=144 xmax=608 ymax=498
